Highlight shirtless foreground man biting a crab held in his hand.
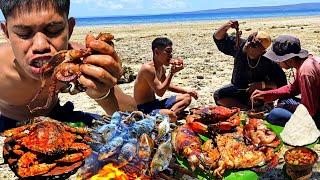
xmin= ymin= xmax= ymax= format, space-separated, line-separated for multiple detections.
xmin=0 ymin=0 xmax=135 ymax=132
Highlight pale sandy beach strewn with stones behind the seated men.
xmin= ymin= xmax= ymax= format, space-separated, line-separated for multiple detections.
xmin=0 ymin=16 xmax=320 ymax=179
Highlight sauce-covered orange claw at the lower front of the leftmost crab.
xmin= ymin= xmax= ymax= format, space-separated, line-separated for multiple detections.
xmin=18 ymin=152 xmax=56 ymax=177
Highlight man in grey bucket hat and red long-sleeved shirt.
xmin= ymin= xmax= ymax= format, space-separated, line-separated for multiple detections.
xmin=251 ymin=35 xmax=320 ymax=127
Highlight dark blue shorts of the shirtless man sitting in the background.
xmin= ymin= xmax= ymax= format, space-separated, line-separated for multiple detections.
xmin=137 ymin=96 xmax=177 ymax=115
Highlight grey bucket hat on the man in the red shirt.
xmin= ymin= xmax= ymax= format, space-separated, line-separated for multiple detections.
xmin=263 ymin=35 xmax=309 ymax=62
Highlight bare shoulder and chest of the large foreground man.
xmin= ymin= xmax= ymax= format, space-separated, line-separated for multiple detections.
xmin=0 ymin=44 xmax=57 ymax=121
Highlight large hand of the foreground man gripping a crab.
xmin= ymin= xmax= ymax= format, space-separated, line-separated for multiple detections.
xmin=79 ymin=36 xmax=122 ymax=99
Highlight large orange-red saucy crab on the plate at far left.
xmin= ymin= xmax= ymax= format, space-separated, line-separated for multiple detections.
xmin=3 ymin=117 xmax=92 ymax=177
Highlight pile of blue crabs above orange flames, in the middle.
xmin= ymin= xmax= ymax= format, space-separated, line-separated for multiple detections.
xmin=78 ymin=111 xmax=176 ymax=179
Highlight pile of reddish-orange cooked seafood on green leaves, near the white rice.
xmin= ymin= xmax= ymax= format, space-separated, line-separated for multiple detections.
xmin=172 ymin=106 xmax=280 ymax=177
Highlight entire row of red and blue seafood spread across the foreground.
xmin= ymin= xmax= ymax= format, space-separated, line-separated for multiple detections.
xmin=4 ymin=106 xmax=280 ymax=180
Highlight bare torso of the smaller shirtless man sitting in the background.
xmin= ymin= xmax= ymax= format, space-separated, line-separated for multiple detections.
xmin=134 ymin=61 xmax=165 ymax=105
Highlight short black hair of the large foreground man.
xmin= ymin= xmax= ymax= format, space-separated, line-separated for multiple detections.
xmin=0 ymin=0 xmax=70 ymax=19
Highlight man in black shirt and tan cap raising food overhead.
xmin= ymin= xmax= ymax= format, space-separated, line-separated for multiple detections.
xmin=213 ymin=21 xmax=287 ymax=109
